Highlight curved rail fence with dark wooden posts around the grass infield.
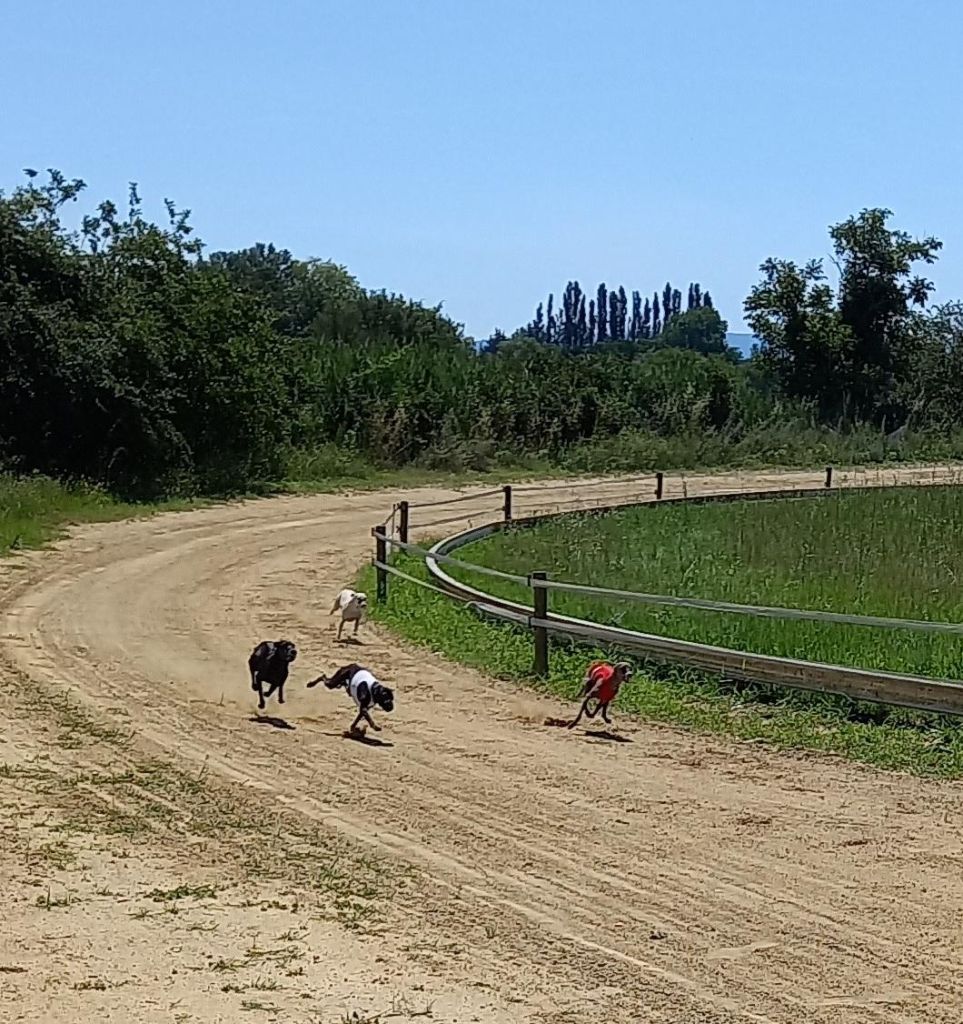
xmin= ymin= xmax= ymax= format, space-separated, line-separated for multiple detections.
xmin=373 ymin=468 xmax=963 ymax=716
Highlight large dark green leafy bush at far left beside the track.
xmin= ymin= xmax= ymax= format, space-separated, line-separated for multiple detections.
xmin=0 ymin=175 xmax=301 ymax=497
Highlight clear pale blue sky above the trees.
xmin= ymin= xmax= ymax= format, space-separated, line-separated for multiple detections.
xmin=7 ymin=0 xmax=963 ymax=337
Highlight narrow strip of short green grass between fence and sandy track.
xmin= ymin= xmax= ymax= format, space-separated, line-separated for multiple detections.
xmin=361 ymin=558 xmax=963 ymax=778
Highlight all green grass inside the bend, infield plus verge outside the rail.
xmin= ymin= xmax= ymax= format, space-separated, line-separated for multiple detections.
xmin=363 ymin=487 xmax=963 ymax=777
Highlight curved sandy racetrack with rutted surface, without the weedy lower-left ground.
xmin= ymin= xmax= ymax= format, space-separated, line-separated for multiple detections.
xmin=0 ymin=470 xmax=963 ymax=1024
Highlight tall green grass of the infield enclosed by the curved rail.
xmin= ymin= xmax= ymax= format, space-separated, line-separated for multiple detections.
xmin=450 ymin=486 xmax=963 ymax=679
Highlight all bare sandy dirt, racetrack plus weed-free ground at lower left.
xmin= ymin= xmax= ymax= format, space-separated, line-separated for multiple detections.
xmin=0 ymin=470 xmax=963 ymax=1024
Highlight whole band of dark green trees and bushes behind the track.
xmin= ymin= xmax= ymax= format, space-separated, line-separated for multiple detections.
xmin=0 ymin=171 xmax=963 ymax=498
